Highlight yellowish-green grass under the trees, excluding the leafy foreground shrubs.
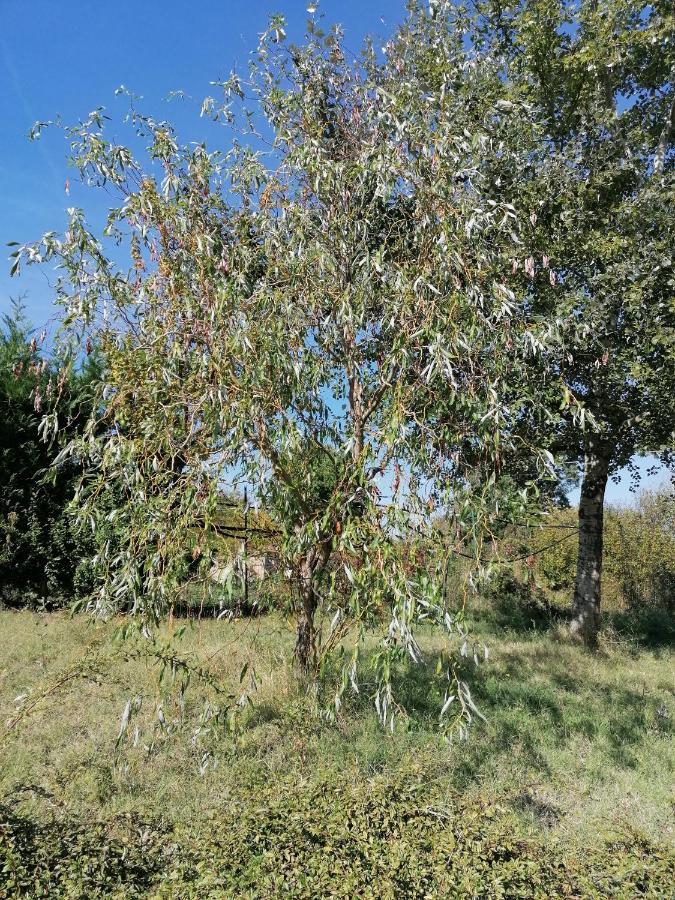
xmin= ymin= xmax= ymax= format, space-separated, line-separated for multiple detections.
xmin=0 ymin=610 xmax=675 ymax=896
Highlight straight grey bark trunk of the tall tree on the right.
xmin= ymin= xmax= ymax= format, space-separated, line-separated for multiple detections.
xmin=570 ymin=447 xmax=609 ymax=647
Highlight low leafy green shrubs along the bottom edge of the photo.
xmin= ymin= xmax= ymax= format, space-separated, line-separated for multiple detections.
xmin=0 ymin=776 xmax=675 ymax=900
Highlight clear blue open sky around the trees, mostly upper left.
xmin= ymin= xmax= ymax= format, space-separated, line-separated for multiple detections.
xmin=0 ymin=0 xmax=663 ymax=502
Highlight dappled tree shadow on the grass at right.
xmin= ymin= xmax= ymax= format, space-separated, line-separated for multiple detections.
xmin=334 ymin=638 xmax=674 ymax=788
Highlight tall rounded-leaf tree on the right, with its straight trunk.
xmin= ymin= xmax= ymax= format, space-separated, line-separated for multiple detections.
xmin=472 ymin=0 xmax=675 ymax=645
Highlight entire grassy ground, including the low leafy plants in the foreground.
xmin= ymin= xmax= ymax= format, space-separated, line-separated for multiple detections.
xmin=0 ymin=600 xmax=675 ymax=897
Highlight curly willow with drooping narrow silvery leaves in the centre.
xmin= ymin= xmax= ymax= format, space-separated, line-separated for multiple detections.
xmin=17 ymin=5 xmax=572 ymax=724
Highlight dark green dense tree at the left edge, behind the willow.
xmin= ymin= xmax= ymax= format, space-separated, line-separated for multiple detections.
xmin=0 ymin=303 xmax=96 ymax=606
